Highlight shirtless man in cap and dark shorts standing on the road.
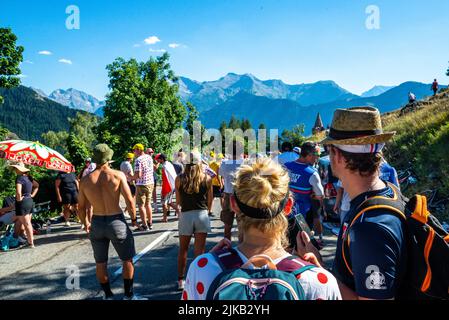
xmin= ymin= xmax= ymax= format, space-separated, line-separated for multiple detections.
xmin=79 ymin=144 xmax=147 ymax=300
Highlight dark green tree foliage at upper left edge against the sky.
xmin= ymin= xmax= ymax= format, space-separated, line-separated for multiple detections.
xmin=0 ymin=28 xmax=24 ymax=104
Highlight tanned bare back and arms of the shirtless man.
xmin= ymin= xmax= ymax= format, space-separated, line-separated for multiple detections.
xmin=79 ymin=164 xmax=136 ymax=225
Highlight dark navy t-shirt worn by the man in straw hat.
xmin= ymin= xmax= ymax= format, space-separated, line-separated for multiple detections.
xmin=333 ymin=187 xmax=407 ymax=299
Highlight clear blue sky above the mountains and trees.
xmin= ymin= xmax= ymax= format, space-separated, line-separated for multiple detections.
xmin=0 ymin=0 xmax=449 ymax=98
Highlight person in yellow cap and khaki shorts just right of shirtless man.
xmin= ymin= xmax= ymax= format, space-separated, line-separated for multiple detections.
xmin=132 ymin=143 xmax=154 ymax=231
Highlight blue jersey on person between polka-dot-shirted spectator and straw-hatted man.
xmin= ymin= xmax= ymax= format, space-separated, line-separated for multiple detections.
xmin=284 ymin=161 xmax=316 ymax=216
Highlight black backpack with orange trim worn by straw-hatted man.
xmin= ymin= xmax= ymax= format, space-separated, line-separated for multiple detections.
xmin=342 ymin=183 xmax=449 ymax=300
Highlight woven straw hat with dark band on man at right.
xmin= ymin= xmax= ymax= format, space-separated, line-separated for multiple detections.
xmin=321 ymin=107 xmax=396 ymax=145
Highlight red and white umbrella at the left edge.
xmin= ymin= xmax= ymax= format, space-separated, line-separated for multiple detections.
xmin=0 ymin=140 xmax=75 ymax=172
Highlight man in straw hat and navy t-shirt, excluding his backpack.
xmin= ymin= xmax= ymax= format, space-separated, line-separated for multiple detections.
xmin=297 ymin=107 xmax=406 ymax=299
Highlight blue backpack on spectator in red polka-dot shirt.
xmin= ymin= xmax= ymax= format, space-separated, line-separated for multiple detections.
xmin=206 ymin=249 xmax=316 ymax=301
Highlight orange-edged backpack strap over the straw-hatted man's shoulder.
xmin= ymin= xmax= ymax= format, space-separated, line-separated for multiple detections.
xmin=341 ymin=182 xmax=408 ymax=275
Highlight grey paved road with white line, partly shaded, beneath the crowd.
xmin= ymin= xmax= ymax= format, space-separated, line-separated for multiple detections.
xmin=0 ymin=191 xmax=335 ymax=300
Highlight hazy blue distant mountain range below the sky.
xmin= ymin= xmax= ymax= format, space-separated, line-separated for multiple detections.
xmin=26 ymin=73 xmax=442 ymax=134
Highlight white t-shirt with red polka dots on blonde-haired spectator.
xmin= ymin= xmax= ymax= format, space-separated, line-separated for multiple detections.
xmin=181 ymin=248 xmax=341 ymax=300
